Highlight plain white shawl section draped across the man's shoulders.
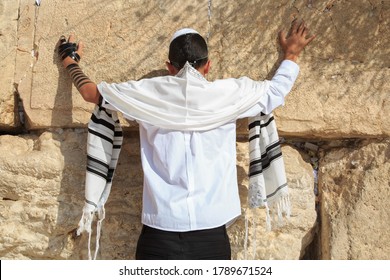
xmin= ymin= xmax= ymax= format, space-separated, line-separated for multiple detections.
xmin=98 ymin=62 xmax=269 ymax=131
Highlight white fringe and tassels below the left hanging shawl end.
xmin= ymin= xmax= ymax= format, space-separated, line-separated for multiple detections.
xmin=77 ymin=205 xmax=106 ymax=260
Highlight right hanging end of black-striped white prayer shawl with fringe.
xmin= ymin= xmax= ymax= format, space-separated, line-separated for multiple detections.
xmin=244 ymin=114 xmax=291 ymax=259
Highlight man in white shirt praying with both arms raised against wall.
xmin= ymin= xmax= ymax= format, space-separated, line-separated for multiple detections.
xmin=59 ymin=20 xmax=314 ymax=259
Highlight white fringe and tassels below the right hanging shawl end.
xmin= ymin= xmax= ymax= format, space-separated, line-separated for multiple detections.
xmin=244 ymin=194 xmax=291 ymax=260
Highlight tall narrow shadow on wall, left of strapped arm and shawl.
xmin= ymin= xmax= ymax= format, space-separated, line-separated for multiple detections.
xmin=45 ymin=38 xmax=79 ymax=259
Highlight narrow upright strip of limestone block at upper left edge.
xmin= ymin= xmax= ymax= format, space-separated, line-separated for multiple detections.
xmin=0 ymin=0 xmax=19 ymax=130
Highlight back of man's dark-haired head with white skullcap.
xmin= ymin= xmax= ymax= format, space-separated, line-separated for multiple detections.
xmin=168 ymin=29 xmax=208 ymax=70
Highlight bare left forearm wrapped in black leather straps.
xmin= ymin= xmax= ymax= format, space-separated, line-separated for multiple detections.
xmin=63 ymin=57 xmax=100 ymax=104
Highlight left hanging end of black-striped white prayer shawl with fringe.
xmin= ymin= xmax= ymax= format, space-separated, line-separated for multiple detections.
xmin=77 ymin=105 xmax=123 ymax=259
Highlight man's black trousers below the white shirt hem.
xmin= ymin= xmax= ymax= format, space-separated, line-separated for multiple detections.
xmin=135 ymin=225 xmax=231 ymax=260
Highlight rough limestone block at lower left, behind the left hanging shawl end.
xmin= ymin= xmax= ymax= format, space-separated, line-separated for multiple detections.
xmin=0 ymin=130 xmax=143 ymax=259
